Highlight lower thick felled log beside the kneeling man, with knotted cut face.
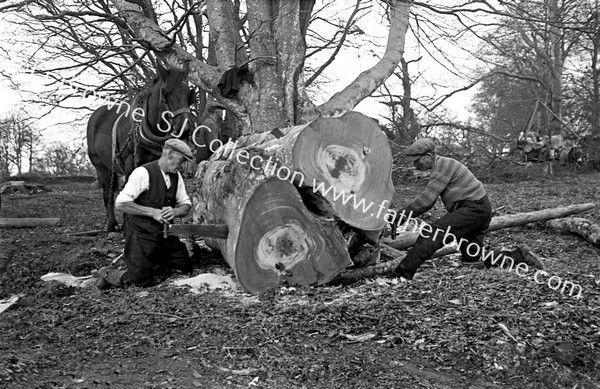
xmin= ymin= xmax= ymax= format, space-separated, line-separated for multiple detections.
xmin=193 ymin=149 xmax=352 ymax=293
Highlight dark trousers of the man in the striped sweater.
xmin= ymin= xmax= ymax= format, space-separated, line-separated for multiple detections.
xmin=395 ymin=195 xmax=492 ymax=280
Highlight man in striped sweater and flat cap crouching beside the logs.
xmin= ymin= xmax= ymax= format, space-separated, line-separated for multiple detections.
xmin=392 ymin=139 xmax=542 ymax=281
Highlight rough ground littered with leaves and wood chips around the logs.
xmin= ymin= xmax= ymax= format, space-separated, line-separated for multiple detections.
xmin=0 ymin=173 xmax=600 ymax=389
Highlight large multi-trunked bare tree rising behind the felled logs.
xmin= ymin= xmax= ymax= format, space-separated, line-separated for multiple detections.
xmin=0 ymin=0 xmax=410 ymax=132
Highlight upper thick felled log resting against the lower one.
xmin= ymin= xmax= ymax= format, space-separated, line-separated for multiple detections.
xmin=229 ymin=112 xmax=394 ymax=231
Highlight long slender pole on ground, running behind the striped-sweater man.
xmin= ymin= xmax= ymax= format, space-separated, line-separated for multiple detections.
xmin=384 ymin=203 xmax=596 ymax=250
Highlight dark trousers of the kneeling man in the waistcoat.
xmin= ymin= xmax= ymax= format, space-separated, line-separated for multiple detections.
xmin=122 ymin=223 xmax=194 ymax=287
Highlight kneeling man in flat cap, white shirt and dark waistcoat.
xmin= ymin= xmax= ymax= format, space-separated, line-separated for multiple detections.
xmin=96 ymin=138 xmax=194 ymax=289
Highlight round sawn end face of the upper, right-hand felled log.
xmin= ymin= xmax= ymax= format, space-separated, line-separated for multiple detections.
xmin=292 ymin=111 xmax=394 ymax=231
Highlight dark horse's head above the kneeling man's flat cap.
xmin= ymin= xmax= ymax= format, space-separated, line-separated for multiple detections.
xmin=149 ymin=65 xmax=196 ymax=139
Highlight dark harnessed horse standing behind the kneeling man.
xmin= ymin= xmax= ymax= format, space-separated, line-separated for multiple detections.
xmin=87 ymin=64 xmax=196 ymax=232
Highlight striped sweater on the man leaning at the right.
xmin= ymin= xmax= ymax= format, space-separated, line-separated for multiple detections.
xmin=404 ymin=156 xmax=486 ymax=217
